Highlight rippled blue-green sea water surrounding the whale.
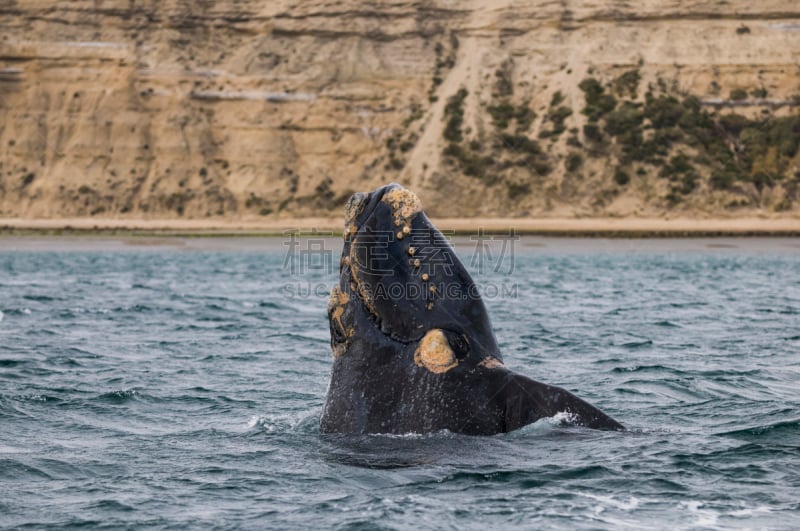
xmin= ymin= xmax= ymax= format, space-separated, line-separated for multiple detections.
xmin=0 ymin=237 xmax=800 ymax=529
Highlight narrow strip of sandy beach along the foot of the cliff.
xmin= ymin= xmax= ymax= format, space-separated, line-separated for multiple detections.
xmin=0 ymin=217 xmax=800 ymax=238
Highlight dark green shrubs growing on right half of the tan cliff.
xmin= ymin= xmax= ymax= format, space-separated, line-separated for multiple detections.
xmin=443 ymin=65 xmax=800 ymax=215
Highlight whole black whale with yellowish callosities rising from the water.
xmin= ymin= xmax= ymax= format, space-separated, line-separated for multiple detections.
xmin=320 ymin=184 xmax=624 ymax=435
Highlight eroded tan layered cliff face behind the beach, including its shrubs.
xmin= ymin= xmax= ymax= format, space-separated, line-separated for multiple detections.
xmin=0 ymin=0 xmax=800 ymax=218
